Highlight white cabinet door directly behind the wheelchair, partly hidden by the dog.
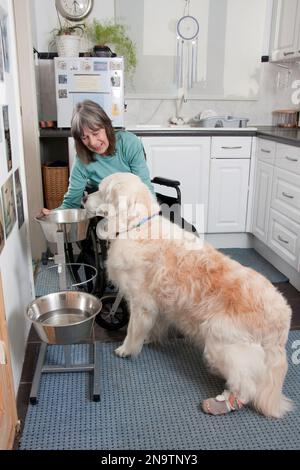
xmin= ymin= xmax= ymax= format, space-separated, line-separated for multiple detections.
xmin=142 ymin=137 xmax=210 ymax=233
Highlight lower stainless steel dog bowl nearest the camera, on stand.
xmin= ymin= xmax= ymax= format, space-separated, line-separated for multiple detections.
xmin=26 ymin=291 xmax=102 ymax=344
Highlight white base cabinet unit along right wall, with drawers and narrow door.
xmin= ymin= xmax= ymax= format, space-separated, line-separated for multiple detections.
xmin=252 ymin=139 xmax=300 ymax=271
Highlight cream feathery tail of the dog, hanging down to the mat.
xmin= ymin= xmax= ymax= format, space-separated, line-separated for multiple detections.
xmin=254 ymin=324 xmax=293 ymax=418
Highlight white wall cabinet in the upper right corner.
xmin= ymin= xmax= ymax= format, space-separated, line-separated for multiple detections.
xmin=270 ymin=0 xmax=300 ymax=62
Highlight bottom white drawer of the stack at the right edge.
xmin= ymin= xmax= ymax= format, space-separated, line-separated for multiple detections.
xmin=268 ymin=209 xmax=300 ymax=269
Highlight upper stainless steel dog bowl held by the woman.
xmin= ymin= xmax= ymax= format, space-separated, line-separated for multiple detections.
xmin=35 ymin=209 xmax=89 ymax=243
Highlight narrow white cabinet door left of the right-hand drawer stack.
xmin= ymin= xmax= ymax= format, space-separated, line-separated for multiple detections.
xmin=252 ymin=161 xmax=273 ymax=243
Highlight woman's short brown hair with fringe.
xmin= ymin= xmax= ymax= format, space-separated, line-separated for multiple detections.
xmin=71 ymin=100 xmax=116 ymax=163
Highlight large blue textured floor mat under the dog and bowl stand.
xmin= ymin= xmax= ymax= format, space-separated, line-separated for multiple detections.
xmin=20 ymin=331 xmax=300 ymax=450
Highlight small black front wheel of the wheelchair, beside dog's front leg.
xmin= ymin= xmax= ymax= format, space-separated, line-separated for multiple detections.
xmin=96 ymin=294 xmax=129 ymax=331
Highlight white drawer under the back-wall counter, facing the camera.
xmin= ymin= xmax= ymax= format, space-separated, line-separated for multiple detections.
xmin=211 ymin=136 xmax=252 ymax=158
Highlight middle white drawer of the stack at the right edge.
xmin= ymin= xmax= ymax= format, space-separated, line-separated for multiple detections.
xmin=271 ymin=167 xmax=300 ymax=224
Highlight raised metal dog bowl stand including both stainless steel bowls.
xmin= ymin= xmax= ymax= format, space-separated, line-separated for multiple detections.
xmin=26 ymin=209 xmax=101 ymax=405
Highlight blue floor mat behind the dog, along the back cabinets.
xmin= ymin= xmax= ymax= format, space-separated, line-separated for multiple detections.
xmin=218 ymin=248 xmax=288 ymax=284
